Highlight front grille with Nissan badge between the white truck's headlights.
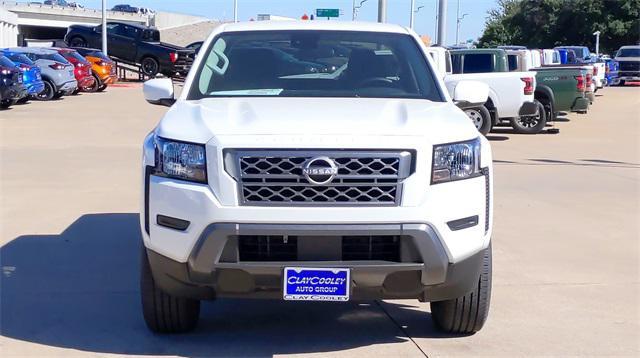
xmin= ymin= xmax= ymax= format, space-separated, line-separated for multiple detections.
xmin=225 ymin=150 xmax=413 ymax=206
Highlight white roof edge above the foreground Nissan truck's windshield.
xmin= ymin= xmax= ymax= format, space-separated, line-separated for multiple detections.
xmin=221 ymin=20 xmax=409 ymax=34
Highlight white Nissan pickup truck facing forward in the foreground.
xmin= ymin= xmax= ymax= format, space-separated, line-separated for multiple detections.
xmin=140 ymin=21 xmax=493 ymax=334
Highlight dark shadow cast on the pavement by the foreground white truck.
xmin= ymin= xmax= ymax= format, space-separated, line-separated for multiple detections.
xmin=0 ymin=213 xmax=441 ymax=356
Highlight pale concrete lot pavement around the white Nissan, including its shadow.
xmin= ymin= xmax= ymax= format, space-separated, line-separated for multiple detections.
xmin=0 ymin=85 xmax=640 ymax=357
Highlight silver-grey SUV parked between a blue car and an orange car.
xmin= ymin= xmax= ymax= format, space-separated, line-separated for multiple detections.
xmin=9 ymin=47 xmax=78 ymax=101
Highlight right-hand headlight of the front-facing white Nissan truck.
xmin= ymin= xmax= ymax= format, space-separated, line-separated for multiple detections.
xmin=431 ymin=138 xmax=480 ymax=184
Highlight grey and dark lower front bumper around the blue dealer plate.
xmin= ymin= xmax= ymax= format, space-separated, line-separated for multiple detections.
xmin=147 ymin=224 xmax=483 ymax=301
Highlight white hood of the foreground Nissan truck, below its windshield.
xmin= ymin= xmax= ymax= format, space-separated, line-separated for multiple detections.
xmin=156 ymin=98 xmax=478 ymax=143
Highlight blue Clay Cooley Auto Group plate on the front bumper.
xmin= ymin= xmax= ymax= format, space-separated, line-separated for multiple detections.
xmin=283 ymin=267 xmax=351 ymax=302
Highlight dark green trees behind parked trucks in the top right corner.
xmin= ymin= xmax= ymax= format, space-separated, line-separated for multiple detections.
xmin=479 ymin=0 xmax=640 ymax=52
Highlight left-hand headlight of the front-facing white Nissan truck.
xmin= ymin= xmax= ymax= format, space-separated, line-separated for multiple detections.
xmin=155 ymin=137 xmax=207 ymax=183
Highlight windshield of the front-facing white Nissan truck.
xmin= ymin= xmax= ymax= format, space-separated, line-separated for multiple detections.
xmin=188 ymin=31 xmax=443 ymax=101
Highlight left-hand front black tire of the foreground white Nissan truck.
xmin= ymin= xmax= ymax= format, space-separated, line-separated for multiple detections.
xmin=140 ymin=247 xmax=200 ymax=333
